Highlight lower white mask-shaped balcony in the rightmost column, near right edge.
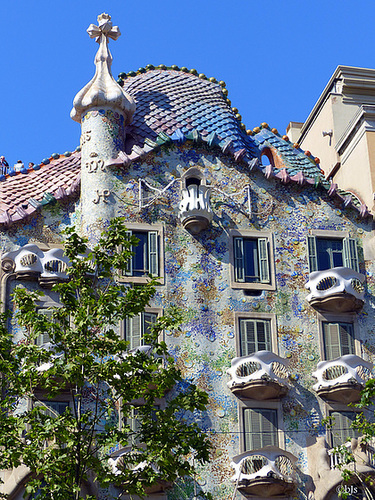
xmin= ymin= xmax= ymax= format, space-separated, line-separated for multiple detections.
xmin=312 ymin=354 xmax=373 ymax=404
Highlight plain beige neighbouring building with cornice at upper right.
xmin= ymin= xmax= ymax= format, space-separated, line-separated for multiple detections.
xmin=287 ymin=66 xmax=375 ymax=213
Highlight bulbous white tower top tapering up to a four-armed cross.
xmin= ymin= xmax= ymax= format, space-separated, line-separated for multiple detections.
xmin=70 ymin=13 xmax=135 ymax=124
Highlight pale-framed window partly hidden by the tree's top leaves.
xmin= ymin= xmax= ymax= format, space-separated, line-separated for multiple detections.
xmin=120 ymin=224 xmax=164 ymax=284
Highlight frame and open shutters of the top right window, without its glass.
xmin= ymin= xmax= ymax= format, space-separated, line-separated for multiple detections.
xmin=306 ymin=229 xmax=360 ymax=273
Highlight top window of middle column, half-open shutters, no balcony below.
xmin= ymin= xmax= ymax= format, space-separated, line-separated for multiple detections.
xmin=231 ymin=231 xmax=274 ymax=290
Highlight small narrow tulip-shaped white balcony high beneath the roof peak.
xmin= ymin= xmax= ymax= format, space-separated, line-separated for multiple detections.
xmin=179 ymin=184 xmax=212 ymax=234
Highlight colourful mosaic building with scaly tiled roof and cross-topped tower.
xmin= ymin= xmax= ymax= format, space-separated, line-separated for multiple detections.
xmin=0 ymin=15 xmax=375 ymax=500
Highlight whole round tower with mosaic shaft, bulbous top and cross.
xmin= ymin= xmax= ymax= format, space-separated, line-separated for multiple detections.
xmin=70 ymin=14 xmax=135 ymax=240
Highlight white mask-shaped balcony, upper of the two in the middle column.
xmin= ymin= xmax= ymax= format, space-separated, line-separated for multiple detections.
xmin=227 ymin=351 xmax=290 ymax=401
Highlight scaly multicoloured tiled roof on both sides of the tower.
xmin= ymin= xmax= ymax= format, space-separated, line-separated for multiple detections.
xmin=0 ymin=67 xmax=368 ymax=226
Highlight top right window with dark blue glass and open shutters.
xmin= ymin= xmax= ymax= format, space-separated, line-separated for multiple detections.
xmin=307 ymin=236 xmax=358 ymax=273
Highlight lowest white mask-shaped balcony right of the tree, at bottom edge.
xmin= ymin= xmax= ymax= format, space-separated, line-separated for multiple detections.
xmin=231 ymin=446 xmax=297 ymax=498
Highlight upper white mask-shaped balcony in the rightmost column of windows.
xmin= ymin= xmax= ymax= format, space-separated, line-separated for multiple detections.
xmin=305 ymin=267 xmax=365 ymax=313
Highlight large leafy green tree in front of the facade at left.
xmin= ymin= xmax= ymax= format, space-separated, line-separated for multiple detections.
xmin=0 ymin=219 xmax=209 ymax=500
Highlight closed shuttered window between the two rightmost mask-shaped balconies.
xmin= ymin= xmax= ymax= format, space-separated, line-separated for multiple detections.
xmin=322 ymin=322 xmax=355 ymax=360
